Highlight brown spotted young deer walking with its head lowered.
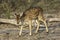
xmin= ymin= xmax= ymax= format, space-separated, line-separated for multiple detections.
xmin=16 ymin=7 xmax=48 ymax=35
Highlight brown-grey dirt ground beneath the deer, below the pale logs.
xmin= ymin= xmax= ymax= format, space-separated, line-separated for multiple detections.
xmin=0 ymin=22 xmax=60 ymax=40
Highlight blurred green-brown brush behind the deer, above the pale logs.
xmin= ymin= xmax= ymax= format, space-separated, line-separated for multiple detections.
xmin=0 ymin=0 xmax=60 ymax=18
